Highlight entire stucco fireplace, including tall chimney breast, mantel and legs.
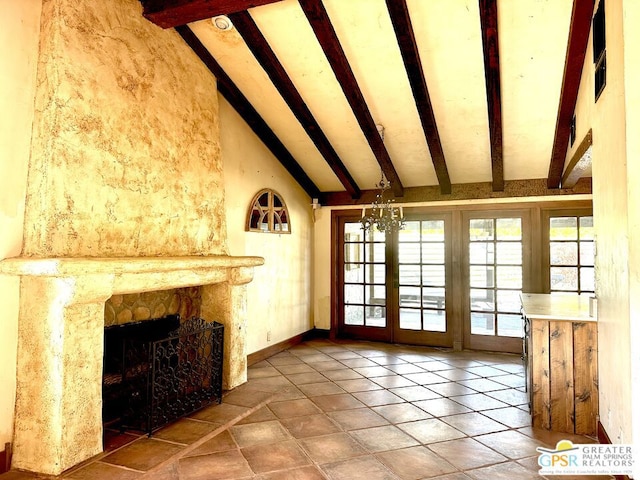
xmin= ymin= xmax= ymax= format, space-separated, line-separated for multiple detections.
xmin=0 ymin=0 xmax=263 ymax=474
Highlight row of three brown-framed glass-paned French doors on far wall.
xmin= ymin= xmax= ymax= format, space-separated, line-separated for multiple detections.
xmin=334 ymin=208 xmax=532 ymax=352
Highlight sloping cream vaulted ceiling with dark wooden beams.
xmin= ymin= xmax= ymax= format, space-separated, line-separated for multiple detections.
xmin=141 ymin=0 xmax=594 ymax=204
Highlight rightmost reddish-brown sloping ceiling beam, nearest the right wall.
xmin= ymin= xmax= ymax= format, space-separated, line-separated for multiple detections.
xmin=547 ymin=0 xmax=595 ymax=188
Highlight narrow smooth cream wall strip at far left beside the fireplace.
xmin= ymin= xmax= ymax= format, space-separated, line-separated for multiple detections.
xmin=0 ymin=0 xmax=41 ymax=450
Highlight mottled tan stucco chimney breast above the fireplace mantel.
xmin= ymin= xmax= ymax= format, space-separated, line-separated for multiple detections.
xmin=23 ymin=0 xmax=227 ymax=256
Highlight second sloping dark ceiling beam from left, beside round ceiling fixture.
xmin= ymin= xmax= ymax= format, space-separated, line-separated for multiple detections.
xmin=229 ymin=12 xmax=360 ymax=198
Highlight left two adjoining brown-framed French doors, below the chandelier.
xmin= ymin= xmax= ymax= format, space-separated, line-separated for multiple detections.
xmin=336 ymin=214 xmax=453 ymax=346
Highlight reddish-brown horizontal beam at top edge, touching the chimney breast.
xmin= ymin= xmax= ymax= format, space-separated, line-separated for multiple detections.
xmin=140 ymin=0 xmax=282 ymax=28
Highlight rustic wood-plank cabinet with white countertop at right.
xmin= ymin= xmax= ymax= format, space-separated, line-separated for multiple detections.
xmin=522 ymin=294 xmax=598 ymax=436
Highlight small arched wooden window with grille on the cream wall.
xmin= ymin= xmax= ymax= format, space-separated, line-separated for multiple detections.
xmin=247 ymin=188 xmax=291 ymax=233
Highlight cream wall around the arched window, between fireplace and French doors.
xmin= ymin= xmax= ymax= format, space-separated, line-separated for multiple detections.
xmin=220 ymin=97 xmax=316 ymax=353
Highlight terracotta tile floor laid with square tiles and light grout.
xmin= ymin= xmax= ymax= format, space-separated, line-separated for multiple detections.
xmin=0 ymin=340 xmax=602 ymax=480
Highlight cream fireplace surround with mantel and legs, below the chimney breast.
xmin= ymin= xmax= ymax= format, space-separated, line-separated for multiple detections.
xmin=0 ymin=255 xmax=264 ymax=475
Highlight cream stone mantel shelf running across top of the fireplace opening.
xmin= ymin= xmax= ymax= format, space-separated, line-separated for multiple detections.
xmin=0 ymin=255 xmax=264 ymax=277
